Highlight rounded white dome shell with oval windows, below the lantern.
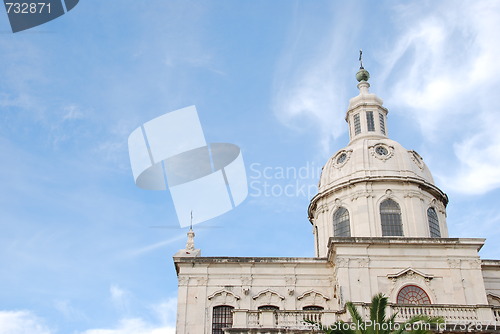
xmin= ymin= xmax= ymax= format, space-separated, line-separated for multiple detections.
xmin=319 ymin=138 xmax=434 ymax=194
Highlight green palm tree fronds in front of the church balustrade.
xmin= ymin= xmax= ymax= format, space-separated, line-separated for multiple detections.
xmin=308 ymin=293 xmax=443 ymax=334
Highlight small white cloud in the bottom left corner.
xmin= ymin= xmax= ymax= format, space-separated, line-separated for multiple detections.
xmin=0 ymin=311 xmax=53 ymax=334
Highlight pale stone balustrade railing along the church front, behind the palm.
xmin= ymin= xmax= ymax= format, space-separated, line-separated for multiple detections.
xmin=233 ymin=304 xmax=500 ymax=329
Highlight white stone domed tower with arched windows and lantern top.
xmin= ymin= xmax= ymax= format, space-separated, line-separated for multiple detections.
xmin=308 ymin=66 xmax=448 ymax=256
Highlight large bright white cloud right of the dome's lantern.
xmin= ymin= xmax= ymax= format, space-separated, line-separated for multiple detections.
xmin=381 ymin=1 xmax=500 ymax=194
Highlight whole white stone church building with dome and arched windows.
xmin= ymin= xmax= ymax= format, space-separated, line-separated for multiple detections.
xmin=174 ymin=66 xmax=500 ymax=334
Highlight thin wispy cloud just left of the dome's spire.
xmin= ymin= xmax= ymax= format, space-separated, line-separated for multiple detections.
xmin=273 ymin=3 xmax=357 ymax=154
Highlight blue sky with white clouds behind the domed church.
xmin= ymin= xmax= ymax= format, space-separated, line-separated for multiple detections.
xmin=0 ymin=0 xmax=500 ymax=334
